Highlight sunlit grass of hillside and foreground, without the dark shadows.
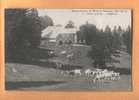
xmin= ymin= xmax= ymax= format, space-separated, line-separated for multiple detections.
xmin=6 ymin=43 xmax=131 ymax=90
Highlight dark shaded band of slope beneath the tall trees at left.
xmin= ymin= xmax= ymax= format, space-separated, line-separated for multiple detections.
xmin=5 ymin=48 xmax=55 ymax=67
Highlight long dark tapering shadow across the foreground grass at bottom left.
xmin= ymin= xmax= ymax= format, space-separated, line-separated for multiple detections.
xmin=5 ymin=81 xmax=65 ymax=90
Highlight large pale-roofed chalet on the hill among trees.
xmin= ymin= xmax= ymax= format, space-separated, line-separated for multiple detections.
xmin=41 ymin=25 xmax=77 ymax=44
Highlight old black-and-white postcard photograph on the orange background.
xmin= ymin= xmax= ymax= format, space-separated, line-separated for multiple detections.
xmin=5 ymin=8 xmax=133 ymax=91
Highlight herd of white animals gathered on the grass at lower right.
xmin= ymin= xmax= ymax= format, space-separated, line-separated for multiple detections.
xmin=55 ymin=61 xmax=120 ymax=82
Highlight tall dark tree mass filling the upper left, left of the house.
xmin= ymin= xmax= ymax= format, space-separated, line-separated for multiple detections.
xmin=5 ymin=9 xmax=48 ymax=58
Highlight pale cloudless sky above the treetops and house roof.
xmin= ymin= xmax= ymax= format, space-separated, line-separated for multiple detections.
xmin=37 ymin=9 xmax=132 ymax=29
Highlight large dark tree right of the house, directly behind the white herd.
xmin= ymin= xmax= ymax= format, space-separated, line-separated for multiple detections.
xmin=89 ymin=26 xmax=121 ymax=68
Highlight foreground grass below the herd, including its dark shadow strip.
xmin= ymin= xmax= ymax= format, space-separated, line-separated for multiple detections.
xmin=6 ymin=63 xmax=131 ymax=91
